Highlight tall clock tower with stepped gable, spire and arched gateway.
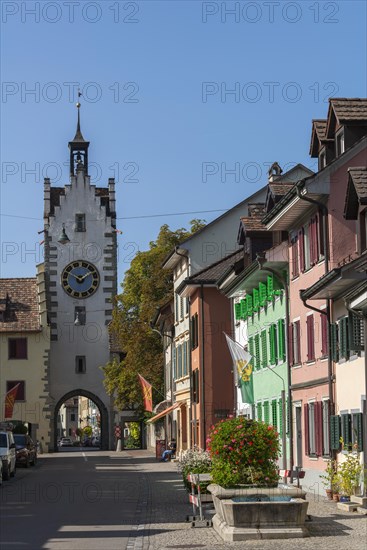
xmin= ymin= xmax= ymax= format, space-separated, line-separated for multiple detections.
xmin=44 ymin=103 xmax=117 ymax=449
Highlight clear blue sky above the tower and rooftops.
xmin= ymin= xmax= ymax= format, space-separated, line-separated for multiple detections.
xmin=1 ymin=0 xmax=367 ymax=281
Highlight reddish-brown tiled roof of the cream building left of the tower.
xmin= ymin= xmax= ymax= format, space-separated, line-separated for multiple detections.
xmin=0 ymin=278 xmax=41 ymax=332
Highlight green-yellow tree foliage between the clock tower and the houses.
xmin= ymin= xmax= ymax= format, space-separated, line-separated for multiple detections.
xmin=103 ymin=220 xmax=205 ymax=412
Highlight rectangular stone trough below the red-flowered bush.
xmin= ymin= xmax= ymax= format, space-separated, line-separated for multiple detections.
xmin=208 ymin=484 xmax=308 ymax=542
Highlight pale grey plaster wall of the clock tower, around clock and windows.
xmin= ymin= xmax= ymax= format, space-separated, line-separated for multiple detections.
xmin=48 ymin=171 xmax=117 ymax=450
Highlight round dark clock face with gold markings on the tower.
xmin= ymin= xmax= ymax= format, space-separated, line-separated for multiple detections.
xmin=61 ymin=260 xmax=99 ymax=298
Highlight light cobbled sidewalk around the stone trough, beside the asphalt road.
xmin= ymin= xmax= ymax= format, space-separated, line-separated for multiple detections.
xmin=125 ymin=451 xmax=367 ymax=550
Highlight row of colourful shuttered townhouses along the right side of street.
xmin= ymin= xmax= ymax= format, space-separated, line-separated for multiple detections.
xmin=153 ymin=98 xmax=367 ymax=498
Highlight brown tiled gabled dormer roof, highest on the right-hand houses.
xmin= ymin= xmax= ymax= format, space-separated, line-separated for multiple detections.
xmin=326 ymin=97 xmax=367 ymax=139
